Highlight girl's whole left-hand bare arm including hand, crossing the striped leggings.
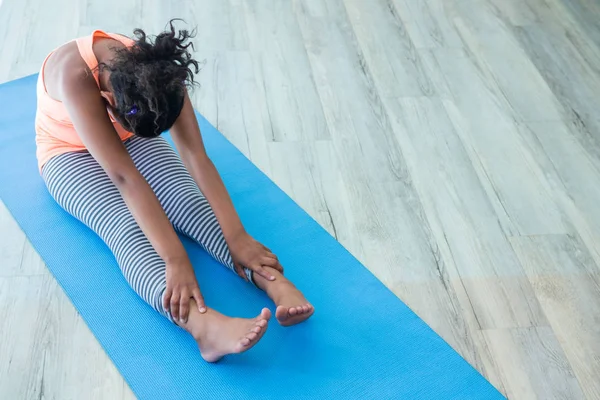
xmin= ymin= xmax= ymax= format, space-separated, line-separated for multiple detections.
xmin=61 ymin=74 xmax=203 ymax=318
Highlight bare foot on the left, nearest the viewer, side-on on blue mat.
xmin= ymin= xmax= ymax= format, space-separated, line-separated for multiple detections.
xmin=178 ymin=303 xmax=271 ymax=362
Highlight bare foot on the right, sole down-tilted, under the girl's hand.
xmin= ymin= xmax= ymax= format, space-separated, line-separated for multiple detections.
xmin=254 ymin=267 xmax=315 ymax=326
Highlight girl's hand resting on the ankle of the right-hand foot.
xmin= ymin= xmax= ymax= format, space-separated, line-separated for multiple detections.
xmin=228 ymin=232 xmax=283 ymax=281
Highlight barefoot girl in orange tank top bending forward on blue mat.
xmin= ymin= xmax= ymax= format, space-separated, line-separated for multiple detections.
xmin=35 ymin=21 xmax=314 ymax=362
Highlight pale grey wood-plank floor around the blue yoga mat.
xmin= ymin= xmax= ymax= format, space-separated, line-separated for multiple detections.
xmin=0 ymin=0 xmax=600 ymax=399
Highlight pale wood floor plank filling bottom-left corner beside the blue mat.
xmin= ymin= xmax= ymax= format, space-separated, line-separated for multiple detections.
xmin=0 ymin=272 xmax=135 ymax=399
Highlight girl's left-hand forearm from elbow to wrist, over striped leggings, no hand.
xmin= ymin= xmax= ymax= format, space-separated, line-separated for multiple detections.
xmin=115 ymin=171 xmax=187 ymax=264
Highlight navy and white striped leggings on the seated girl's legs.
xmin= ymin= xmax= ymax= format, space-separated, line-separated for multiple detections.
xmin=42 ymin=137 xmax=252 ymax=321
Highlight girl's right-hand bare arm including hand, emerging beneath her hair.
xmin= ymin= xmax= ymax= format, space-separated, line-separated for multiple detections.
xmin=171 ymin=94 xmax=283 ymax=280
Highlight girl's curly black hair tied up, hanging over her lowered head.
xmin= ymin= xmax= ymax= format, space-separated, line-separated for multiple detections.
xmin=100 ymin=20 xmax=199 ymax=137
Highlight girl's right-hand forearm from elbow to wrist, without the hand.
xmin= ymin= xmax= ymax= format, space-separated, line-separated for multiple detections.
xmin=184 ymin=155 xmax=245 ymax=243
